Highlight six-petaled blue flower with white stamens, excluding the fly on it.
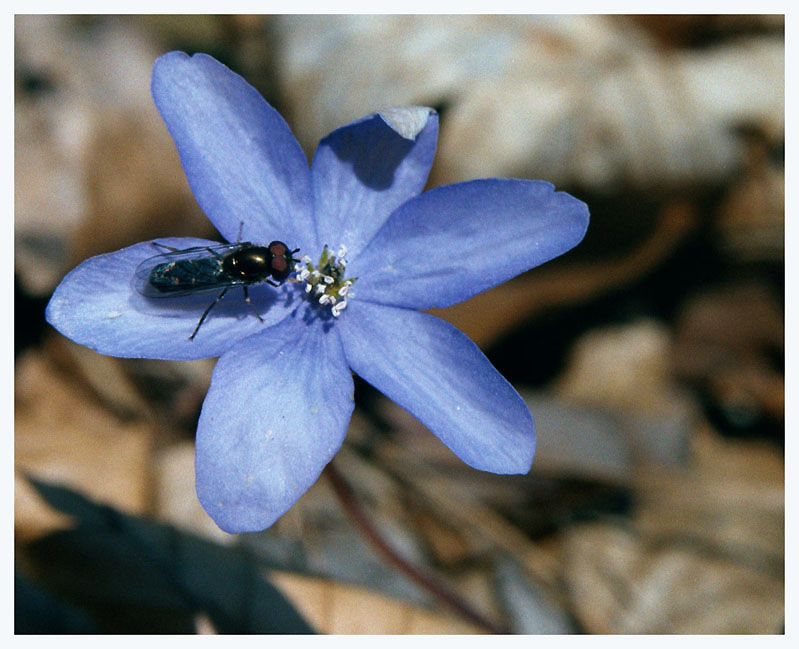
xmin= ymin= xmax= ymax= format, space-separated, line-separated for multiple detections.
xmin=47 ymin=52 xmax=588 ymax=532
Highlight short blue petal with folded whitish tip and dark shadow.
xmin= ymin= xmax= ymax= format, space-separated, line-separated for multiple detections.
xmin=311 ymin=107 xmax=438 ymax=255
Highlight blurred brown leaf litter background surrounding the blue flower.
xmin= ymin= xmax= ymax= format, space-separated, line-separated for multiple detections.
xmin=14 ymin=15 xmax=785 ymax=634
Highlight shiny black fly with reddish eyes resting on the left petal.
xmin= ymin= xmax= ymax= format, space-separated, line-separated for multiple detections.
xmin=135 ymin=241 xmax=299 ymax=340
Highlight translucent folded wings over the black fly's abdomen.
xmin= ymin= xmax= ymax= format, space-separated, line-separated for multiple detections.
xmin=134 ymin=244 xmax=243 ymax=298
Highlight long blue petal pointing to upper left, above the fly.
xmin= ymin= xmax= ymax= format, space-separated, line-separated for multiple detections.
xmin=151 ymin=52 xmax=315 ymax=247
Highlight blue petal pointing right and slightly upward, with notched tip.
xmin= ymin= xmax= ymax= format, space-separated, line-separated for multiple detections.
xmin=347 ymin=179 xmax=588 ymax=309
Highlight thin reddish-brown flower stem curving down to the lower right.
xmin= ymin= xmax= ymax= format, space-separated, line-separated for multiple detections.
xmin=325 ymin=462 xmax=510 ymax=634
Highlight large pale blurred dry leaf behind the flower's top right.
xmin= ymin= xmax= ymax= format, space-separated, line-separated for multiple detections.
xmin=275 ymin=15 xmax=785 ymax=188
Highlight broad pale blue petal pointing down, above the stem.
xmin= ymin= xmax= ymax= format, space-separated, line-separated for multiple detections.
xmin=196 ymin=319 xmax=353 ymax=533
